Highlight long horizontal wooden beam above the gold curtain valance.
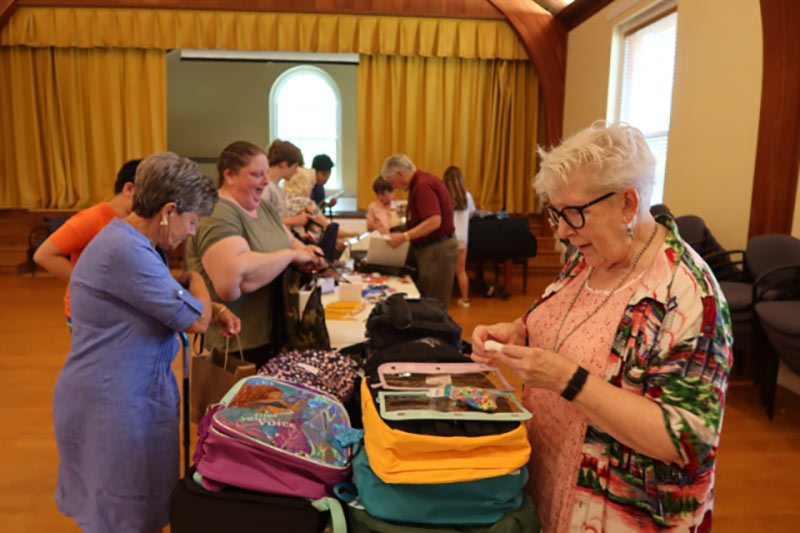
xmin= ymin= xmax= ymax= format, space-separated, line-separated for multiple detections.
xmin=17 ymin=0 xmax=503 ymax=19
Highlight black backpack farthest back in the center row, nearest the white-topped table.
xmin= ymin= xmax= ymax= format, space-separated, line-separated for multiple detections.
xmin=367 ymin=293 xmax=461 ymax=350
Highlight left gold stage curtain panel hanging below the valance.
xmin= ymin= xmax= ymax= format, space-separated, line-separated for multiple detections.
xmin=0 ymin=46 xmax=167 ymax=208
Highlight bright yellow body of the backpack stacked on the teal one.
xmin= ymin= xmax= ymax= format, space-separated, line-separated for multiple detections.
xmin=361 ymin=379 xmax=531 ymax=483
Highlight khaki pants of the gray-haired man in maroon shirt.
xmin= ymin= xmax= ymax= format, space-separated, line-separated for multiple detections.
xmin=414 ymin=237 xmax=458 ymax=309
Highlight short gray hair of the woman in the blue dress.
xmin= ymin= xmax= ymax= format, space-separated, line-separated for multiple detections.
xmin=133 ymin=152 xmax=219 ymax=218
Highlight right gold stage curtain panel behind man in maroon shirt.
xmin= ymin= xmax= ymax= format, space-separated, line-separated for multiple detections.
xmin=357 ymin=55 xmax=539 ymax=213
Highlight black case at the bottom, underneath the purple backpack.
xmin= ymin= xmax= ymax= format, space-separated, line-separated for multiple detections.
xmin=169 ymin=468 xmax=329 ymax=533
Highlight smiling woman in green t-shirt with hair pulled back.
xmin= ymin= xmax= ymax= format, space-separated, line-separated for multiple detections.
xmin=186 ymin=141 xmax=323 ymax=366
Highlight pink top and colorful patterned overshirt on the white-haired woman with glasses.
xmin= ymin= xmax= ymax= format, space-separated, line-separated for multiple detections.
xmin=523 ymin=215 xmax=733 ymax=533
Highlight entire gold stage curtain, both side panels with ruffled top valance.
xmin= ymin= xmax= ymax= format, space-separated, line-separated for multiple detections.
xmin=0 ymin=7 xmax=538 ymax=212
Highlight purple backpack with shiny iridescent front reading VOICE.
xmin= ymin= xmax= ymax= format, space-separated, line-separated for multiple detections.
xmin=195 ymin=376 xmax=350 ymax=499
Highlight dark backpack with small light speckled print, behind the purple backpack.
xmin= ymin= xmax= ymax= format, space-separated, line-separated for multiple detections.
xmin=258 ymin=350 xmax=358 ymax=402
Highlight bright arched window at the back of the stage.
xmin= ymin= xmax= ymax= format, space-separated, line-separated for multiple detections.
xmin=269 ymin=65 xmax=342 ymax=189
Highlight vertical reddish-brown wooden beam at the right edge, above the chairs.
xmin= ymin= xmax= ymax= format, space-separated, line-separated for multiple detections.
xmin=748 ymin=0 xmax=800 ymax=238
